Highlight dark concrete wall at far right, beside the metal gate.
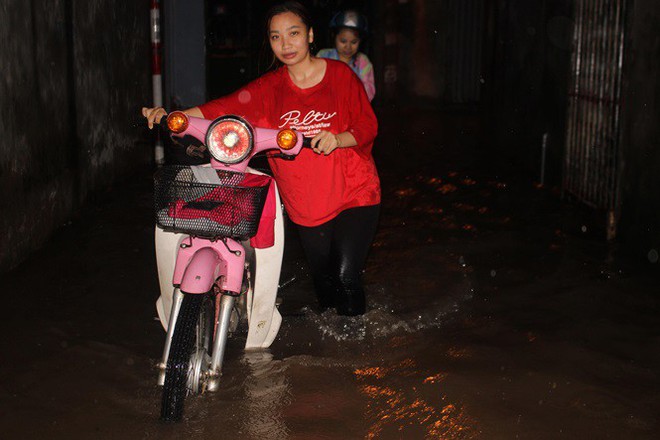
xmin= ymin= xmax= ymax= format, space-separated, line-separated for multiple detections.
xmin=619 ymin=0 xmax=660 ymax=264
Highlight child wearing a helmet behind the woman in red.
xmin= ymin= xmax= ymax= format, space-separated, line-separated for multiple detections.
xmin=316 ymin=10 xmax=376 ymax=101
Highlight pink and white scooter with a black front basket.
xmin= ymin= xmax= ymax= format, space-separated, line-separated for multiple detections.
xmin=154 ymin=112 xmax=304 ymax=421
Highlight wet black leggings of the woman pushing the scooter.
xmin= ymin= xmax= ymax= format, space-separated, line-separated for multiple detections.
xmin=298 ymin=205 xmax=380 ymax=316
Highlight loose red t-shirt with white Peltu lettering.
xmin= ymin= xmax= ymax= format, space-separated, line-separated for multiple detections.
xmin=199 ymin=60 xmax=380 ymax=226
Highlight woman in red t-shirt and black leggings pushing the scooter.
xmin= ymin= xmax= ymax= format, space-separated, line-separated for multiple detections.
xmin=142 ymin=1 xmax=380 ymax=316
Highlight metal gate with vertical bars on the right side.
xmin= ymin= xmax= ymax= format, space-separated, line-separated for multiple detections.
xmin=563 ymin=0 xmax=626 ymax=220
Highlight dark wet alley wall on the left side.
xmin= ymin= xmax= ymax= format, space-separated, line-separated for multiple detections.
xmin=0 ymin=0 xmax=151 ymax=271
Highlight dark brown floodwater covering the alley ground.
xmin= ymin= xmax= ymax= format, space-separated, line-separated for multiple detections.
xmin=0 ymin=111 xmax=660 ymax=439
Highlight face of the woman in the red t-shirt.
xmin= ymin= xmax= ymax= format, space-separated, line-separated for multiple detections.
xmin=268 ymin=12 xmax=314 ymax=66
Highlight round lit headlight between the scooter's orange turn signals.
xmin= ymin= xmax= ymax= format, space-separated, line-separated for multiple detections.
xmin=206 ymin=116 xmax=254 ymax=164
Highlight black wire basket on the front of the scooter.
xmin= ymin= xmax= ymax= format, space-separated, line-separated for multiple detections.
xmin=154 ymin=165 xmax=270 ymax=240
